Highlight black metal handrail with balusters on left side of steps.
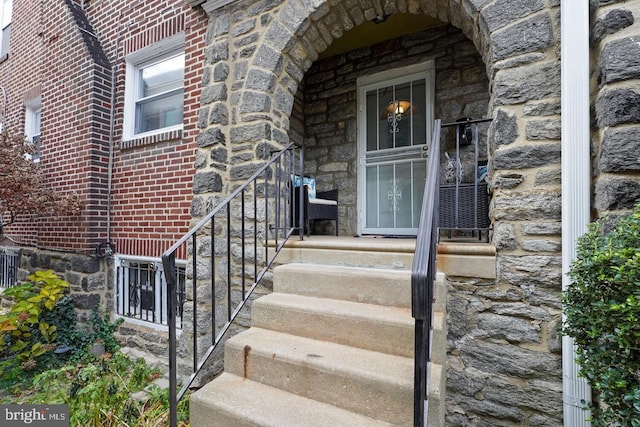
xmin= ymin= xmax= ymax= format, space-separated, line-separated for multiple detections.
xmin=162 ymin=143 xmax=304 ymax=426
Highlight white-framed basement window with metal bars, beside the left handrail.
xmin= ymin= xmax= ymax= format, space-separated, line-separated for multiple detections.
xmin=115 ymin=256 xmax=186 ymax=327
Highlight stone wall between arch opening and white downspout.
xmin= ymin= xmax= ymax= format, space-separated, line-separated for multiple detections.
xmin=447 ymin=1 xmax=563 ymax=426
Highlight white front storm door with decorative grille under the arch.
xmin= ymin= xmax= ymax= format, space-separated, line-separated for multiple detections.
xmin=358 ymin=62 xmax=434 ymax=236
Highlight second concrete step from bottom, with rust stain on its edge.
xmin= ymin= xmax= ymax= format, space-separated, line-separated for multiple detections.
xmin=225 ymin=328 xmax=414 ymax=425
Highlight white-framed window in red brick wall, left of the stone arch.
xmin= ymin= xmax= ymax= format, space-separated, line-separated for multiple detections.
xmin=123 ymin=35 xmax=185 ymax=139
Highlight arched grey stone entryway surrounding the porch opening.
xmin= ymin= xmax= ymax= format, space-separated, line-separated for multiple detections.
xmin=193 ymin=0 xmax=562 ymax=425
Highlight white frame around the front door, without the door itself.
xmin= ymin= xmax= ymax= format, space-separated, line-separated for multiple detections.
xmin=357 ymin=60 xmax=435 ymax=235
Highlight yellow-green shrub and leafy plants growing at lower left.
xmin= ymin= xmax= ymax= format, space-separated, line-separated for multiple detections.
xmin=0 ymin=270 xmax=189 ymax=427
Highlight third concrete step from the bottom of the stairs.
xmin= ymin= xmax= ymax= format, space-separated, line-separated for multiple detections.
xmin=251 ymin=293 xmax=414 ymax=357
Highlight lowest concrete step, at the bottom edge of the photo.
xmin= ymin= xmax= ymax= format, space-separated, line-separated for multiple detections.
xmin=190 ymin=373 xmax=398 ymax=427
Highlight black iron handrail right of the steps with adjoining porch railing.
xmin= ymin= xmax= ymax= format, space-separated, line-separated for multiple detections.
xmin=411 ymin=119 xmax=491 ymax=427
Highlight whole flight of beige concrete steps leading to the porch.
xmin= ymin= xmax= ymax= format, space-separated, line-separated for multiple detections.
xmin=190 ymin=247 xmax=447 ymax=427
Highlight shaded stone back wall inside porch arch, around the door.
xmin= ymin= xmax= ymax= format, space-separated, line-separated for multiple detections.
xmin=301 ymin=25 xmax=490 ymax=236
